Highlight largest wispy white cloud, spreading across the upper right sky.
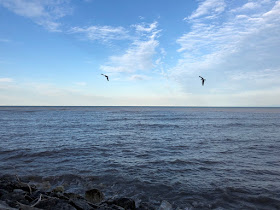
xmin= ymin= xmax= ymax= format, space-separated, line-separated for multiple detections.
xmin=170 ymin=0 xmax=280 ymax=92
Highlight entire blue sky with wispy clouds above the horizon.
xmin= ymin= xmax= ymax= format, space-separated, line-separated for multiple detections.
xmin=0 ymin=0 xmax=280 ymax=106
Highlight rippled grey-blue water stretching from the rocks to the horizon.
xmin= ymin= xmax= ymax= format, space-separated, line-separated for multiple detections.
xmin=0 ymin=107 xmax=280 ymax=209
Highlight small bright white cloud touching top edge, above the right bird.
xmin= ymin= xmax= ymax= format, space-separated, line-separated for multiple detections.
xmin=185 ymin=0 xmax=226 ymax=20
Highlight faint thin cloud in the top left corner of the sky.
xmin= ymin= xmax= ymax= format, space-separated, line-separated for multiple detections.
xmin=0 ymin=0 xmax=71 ymax=31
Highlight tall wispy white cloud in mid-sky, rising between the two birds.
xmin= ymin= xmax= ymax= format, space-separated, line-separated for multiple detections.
xmin=101 ymin=22 xmax=160 ymax=73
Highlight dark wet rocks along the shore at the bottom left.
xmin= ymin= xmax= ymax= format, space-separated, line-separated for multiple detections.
xmin=0 ymin=175 xmax=172 ymax=210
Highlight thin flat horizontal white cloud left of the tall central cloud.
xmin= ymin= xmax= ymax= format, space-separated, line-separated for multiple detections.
xmin=69 ymin=26 xmax=128 ymax=42
